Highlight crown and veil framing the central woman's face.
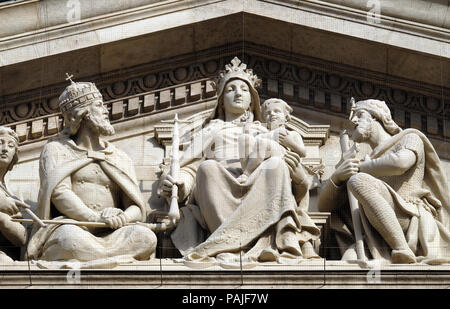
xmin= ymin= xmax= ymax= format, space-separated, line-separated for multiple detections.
xmin=214 ymin=57 xmax=261 ymax=122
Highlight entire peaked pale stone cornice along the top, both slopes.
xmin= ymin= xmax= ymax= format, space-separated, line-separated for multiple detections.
xmin=0 ymin=0 xmax=450 ymax=66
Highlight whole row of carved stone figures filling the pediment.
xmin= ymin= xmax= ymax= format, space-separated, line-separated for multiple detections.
xmin=0 ymin=58 xmax=442 ymax=268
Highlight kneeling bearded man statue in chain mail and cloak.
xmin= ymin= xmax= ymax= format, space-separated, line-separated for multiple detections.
xmin=318 ymin=100 xmax=450 ymax=264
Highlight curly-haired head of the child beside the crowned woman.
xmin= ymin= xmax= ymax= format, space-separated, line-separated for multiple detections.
xmin=261 ymin=99 xmax=293 ymax=130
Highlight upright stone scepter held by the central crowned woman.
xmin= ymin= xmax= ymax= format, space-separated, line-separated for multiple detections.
xmin=161 ymin=114 xmax=192 ymax=223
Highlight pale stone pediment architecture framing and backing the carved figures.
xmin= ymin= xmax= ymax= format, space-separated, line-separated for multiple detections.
xmin=0 ymin=0 xmax=450 ymax=288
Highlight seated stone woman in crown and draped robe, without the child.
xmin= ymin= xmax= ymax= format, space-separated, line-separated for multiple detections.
xmin=159 ymin=58 xmax=320 ymax=264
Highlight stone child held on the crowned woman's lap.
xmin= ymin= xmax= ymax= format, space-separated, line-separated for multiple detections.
xmin=237 ymin=99 xmax=306 ymax=183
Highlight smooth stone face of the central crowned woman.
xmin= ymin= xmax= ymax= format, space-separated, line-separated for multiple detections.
xmin=223 ymin=79 xmax=252 ymax=114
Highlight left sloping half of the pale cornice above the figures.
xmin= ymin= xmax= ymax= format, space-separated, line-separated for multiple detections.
xmin=0 ymin=0 xmax=232 ymax=66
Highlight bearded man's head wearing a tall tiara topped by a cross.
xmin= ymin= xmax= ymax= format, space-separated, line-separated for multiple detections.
xmin=59 ymin=76 xmax=114 ymax=135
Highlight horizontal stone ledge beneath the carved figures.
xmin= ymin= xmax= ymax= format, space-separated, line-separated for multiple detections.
xmin=0 ymin=259 xmax=450 ymax=293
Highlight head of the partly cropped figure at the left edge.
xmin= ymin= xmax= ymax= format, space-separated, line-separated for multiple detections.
xmin=0 ymin=126 xmax=19 ymax=171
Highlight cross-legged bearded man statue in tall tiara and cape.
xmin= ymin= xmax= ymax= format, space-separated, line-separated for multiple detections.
xmin=28 ymin=76 xmax=156 ymax=264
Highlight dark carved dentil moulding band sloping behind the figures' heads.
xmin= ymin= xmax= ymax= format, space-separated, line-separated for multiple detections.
xmin=0 ymin=42 xmax=450 ymax=139
